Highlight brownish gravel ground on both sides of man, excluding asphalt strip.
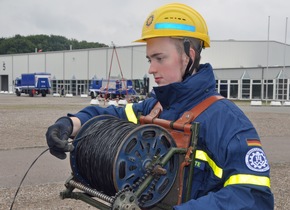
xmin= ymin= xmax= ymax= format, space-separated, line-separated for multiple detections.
xmin=0 ymin=94 xmax=290 ymax=210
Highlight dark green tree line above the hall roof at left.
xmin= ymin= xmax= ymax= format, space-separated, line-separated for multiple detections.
xmin=0 ymin=34 xmax=108 ymax=54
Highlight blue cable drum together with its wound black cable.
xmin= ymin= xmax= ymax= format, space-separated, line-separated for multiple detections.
xmin=70 ymin=115 xmax=178 ymax=207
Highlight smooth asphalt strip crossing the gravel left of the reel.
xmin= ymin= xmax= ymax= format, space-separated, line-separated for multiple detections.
xmin=0 ymin=147 xmax=71 ymax=188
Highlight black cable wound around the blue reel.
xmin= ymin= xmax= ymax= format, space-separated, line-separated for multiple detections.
xmin=75 ymin=118 xmax=138 ymax=195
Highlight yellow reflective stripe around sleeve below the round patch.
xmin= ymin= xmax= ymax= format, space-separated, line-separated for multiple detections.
xmin=224 ymin=174 xmax=270 ymax=188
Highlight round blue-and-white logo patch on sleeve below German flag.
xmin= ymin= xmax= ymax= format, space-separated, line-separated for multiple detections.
xmin=245 ymin=148 xmax=270 ymax=172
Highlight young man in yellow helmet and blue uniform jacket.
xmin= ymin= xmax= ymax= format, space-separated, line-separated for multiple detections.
xmin=46 ymin=3 xmax=274 ymax=210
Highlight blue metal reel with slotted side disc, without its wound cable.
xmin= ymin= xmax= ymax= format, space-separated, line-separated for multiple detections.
xmin=70 ymin=115 xmax=179 ymax=208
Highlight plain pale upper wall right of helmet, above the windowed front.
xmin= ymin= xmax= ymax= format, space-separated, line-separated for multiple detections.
xmin=201 ymin=41 xmax=290 ymax=68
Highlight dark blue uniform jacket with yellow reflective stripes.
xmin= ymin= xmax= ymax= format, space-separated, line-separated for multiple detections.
xmin=69 ymin=64 xmax=274 ymax=210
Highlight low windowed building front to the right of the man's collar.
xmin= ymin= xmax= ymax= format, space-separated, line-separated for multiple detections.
xmin=214 ymin=66 xmax=290 ymax=101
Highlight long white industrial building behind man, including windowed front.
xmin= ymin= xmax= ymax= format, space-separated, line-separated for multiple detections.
xmin=0 ymin=40 xmax=290 ymax=101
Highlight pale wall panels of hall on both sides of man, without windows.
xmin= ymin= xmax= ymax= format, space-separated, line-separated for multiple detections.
xmin=0 ymin=40 xmax=290 ymax=98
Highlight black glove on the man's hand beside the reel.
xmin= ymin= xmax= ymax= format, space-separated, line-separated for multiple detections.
xmin=46 ymin=117 xmax=74 ymax=159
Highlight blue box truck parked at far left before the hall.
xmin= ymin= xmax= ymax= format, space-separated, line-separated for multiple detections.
xmin=15 ymin=72 xmax=51 ymax=97
